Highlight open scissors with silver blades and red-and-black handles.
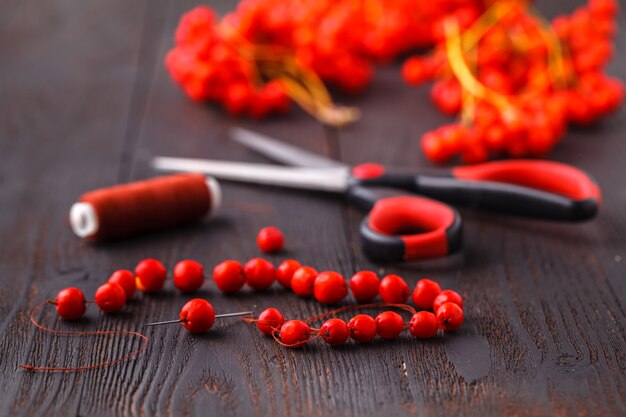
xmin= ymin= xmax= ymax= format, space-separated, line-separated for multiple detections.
xmin=152 ymin=128 xmax=601 ymax=262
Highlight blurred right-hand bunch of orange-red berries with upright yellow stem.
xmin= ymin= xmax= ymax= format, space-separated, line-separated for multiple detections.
xmin=403 ymin=0 xmax=624 ymax=163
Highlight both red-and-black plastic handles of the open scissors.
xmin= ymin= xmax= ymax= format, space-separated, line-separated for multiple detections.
xmin=349 ymin=160 xmax=601 ymax=261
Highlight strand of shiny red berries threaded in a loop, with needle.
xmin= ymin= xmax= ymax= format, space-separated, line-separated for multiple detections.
xmin=47 ymin=258 xmax=464 ymax=352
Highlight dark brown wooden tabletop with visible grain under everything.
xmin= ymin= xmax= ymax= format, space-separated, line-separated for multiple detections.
xmin=0 ymin=0 xmax=626 ymax=416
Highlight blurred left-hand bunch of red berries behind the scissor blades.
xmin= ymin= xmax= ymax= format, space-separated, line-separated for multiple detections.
xmin=165 ymin=0 xmax=482 ymax=122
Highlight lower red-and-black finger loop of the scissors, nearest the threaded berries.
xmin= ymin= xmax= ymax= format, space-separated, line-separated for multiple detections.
xmin=360 ymin=196 xmax=462 ymax=262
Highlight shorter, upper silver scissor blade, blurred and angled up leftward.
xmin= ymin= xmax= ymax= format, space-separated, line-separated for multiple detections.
xmin=230 ymin=127 xmax=346 ymax=168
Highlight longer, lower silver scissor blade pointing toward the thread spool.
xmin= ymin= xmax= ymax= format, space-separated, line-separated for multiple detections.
xmin=152 ymin=156 xmax=349 ymax=192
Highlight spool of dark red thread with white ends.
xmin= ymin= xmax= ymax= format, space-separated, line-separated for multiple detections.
xmin=70 ymin=174 xmax=221 ymax=241
